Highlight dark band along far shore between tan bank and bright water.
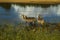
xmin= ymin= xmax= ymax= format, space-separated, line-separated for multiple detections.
xmin=0 ymin=3 xmax=59 ymax=9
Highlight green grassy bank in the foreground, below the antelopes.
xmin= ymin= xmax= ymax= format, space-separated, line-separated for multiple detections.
xmin=0 ymin=24 xmax=60 ymax=40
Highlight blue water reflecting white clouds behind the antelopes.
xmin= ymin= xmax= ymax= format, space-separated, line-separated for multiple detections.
xmin=0 ymin=4 xmax=60 ymax=24
